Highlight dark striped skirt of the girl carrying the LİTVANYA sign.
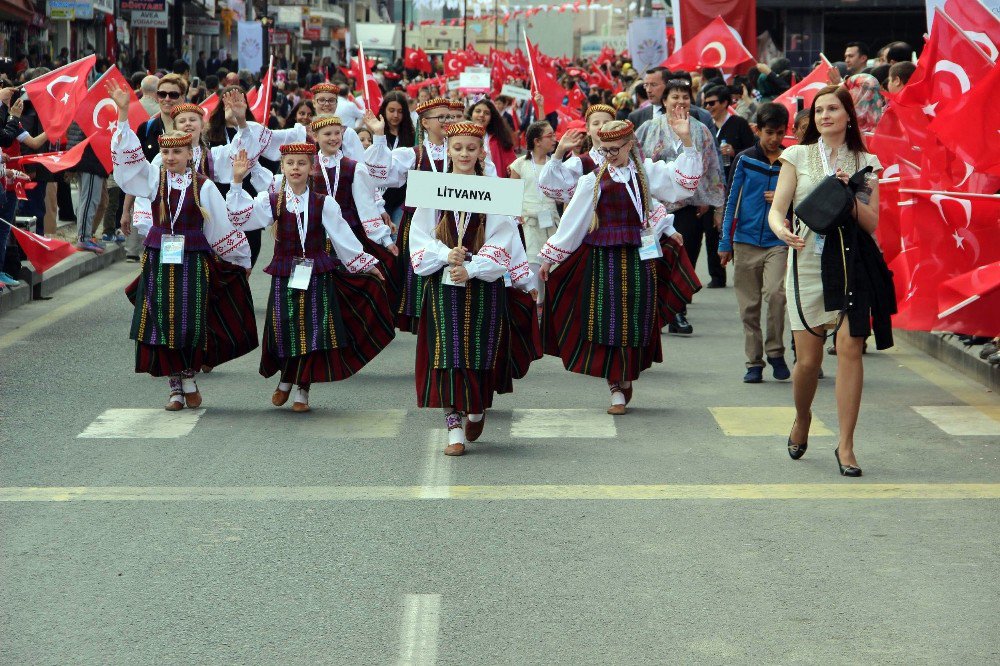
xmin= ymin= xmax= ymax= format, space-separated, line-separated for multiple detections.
xmin=416 ymin=272 xmax=509 ymax=414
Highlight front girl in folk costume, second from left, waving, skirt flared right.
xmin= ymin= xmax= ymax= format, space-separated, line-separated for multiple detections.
xmin=226 ymin=143 xmax=394 ymax=412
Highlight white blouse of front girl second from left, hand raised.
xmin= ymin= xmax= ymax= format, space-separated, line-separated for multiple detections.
xmin=226 ymin=181 xmax=377 ymax=273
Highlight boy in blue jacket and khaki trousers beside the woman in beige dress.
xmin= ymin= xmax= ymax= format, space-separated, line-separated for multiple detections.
xmin=719 ymin=103 xmax=791 ymax=384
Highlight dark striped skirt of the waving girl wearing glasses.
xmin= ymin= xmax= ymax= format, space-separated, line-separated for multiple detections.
xmin=542 ymin=245 xmax=663 ymax=381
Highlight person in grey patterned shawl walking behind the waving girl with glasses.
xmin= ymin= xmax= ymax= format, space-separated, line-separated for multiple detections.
xmin=636 ymin=78 xmax=726 ymax=335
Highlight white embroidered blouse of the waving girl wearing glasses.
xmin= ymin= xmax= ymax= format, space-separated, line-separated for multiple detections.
xmin=538 ymin=160 xmax=697 ymax=264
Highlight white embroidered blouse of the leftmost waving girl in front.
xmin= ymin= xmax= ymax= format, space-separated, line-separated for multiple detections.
xmin=111 ymin=123 xmax=250 ymax=268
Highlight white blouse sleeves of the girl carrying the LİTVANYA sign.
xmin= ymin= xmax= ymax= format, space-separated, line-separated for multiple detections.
xmin=410 ymin=208 xmax=530 ymax=282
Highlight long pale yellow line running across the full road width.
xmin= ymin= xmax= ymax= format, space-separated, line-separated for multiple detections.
xmin=0 ymin=481 xmax=1000 ymax=502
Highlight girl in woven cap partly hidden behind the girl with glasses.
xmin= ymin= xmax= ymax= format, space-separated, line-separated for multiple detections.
xmin=538 ymin=104 xmax=615 ymax=203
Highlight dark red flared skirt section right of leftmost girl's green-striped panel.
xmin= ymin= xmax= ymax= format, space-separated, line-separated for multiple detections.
xmin=205 ymin=257 xmax=259 ymax=367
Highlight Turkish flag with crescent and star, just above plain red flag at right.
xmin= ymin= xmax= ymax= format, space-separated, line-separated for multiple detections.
xmin=896 ymin=9 xmax=993 ymax=126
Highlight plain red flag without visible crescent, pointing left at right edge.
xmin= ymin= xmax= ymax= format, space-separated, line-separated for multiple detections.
xmin=924 ymin=65 xmax=1000 ymax=174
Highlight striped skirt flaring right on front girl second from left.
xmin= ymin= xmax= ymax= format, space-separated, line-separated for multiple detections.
xmin=260 ymin=268 xmax=395 ymax=384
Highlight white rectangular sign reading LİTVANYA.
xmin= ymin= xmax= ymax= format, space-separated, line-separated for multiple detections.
xmin=406 ymin=170 xmax=524 ymax=217
